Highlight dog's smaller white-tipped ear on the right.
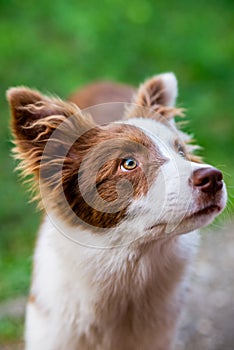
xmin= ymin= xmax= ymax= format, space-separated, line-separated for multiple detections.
xmin=126 ymin=73 xmax=182 ymax=119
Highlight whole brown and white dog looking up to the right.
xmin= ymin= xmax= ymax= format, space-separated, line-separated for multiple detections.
xmin=7 ymin=73 xmax=227 ymax=350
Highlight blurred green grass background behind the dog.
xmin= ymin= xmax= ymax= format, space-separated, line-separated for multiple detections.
xmin=0 ymin=0 xmax=234 ymax=344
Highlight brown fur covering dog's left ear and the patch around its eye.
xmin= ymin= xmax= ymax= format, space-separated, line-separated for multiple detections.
xmin=7 ymin=89 xmax=164 ymax=228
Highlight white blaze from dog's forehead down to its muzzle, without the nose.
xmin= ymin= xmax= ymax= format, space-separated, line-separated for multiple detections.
xmin=124 ymin=118 xmax=192 ymax=230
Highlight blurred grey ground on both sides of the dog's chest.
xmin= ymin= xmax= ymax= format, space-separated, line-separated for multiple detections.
xmin=0 ymin=222 xmax=234 ymax=350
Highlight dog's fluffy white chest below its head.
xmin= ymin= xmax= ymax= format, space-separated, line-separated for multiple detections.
xmin=32 ymin=217 xmax=197 ymax=350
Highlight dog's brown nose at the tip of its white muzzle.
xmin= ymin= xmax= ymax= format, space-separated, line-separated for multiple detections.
xmin=191 ymin=168 xmax=223 ymax=194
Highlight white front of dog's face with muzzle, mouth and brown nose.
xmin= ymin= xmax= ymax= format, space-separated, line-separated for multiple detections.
xmin=122 ymin=119 xmax=226 ymax=238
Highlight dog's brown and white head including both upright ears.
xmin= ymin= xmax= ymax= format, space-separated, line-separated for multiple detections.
xmin=8 ymin=73 xmax=226 ymax=243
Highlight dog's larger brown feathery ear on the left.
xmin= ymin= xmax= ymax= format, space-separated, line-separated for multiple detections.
xmin=7 ymin=87 xmax=95 ymax=174
